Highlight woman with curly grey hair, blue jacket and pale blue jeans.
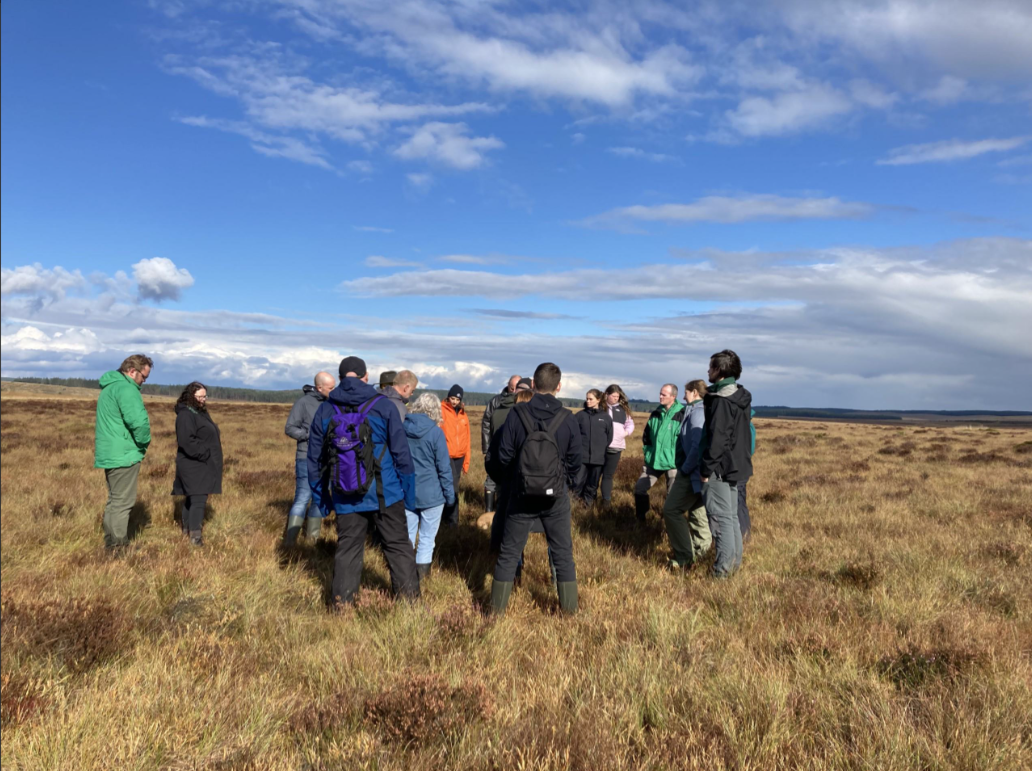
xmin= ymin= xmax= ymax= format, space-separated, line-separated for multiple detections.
xmin=398 ymin=392 xmax=455 ymax=580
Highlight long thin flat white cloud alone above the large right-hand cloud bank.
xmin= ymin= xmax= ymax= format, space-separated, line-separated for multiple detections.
xmin=578 ymin=195 xmax=874 ymax=229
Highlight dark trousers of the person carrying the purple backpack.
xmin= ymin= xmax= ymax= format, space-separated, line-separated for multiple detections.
xmin=333 ymin=501 xmax=419 ymax=603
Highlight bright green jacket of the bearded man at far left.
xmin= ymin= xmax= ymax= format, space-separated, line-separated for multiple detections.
xmin=93 ymin=370 xmax=151 ymax=469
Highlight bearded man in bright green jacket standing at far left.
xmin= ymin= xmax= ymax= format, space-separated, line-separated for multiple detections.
xmin=93 ymin=353 xmax=154 ymax=554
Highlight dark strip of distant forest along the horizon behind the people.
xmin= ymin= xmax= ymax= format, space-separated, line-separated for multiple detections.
xmin=4 ymin=378 xmax=1032 ymax=420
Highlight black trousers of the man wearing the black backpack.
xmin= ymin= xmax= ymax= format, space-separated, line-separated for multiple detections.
xmin=494 ymin=491 xmax=577 ymax=583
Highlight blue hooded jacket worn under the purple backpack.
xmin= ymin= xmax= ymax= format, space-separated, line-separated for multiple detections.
xmin=308 ymin=378 xmax=416 ymax=515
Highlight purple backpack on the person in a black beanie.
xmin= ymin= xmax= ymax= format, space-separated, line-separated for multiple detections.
xmin=325 ymin=394 xmax=387 ymax=495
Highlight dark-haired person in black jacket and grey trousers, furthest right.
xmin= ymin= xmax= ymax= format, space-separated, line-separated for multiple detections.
xmin=699 ymin=350 xmax=752 ymax=578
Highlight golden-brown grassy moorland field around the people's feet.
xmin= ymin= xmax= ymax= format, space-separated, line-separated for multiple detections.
xmin=0 ymin=389 xmax=1032 ymax=771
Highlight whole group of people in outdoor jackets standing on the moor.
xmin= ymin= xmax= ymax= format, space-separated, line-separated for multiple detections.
xmin=96 ymin=351 xmax=754 ymax=613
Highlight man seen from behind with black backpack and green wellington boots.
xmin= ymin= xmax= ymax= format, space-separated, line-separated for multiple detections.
xmin=491 ymin=362 xmax=581 ymax=614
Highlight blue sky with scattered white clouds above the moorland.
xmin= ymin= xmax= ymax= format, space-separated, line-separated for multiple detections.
xmin=0 ymin=0 xmax=1032 ymax=410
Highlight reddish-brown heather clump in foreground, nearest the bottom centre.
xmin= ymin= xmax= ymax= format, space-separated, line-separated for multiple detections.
xmin=364 ymin=675 xmax=494 ymax=744
